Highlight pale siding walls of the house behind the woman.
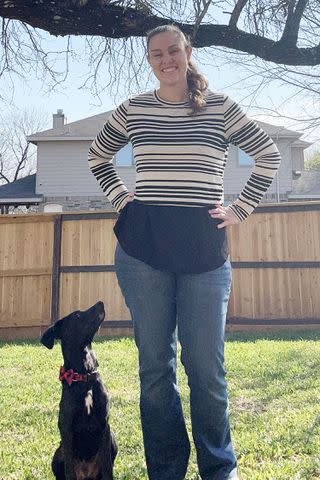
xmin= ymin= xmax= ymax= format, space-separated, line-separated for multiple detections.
xmin=36 ymin=133 xmax=303 ymax=210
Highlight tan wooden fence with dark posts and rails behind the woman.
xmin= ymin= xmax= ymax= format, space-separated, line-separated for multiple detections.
xmin=0 ymin=202 xmax=320 ymax=339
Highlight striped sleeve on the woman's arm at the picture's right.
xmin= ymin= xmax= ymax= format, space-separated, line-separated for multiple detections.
xmin=224 ymin=97 xmax=281 ymax=221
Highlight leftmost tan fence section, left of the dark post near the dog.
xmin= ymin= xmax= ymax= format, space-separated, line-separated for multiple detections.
xmin=0 ymin=215 xmax=53 ymax=336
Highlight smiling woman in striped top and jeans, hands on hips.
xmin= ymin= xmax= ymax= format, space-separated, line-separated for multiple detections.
xmin=89 ymin=25 xmax=280 ymax=480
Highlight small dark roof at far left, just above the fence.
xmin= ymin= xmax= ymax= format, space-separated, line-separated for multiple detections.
xmin=0 ymin=173 xmax=43 ymax=205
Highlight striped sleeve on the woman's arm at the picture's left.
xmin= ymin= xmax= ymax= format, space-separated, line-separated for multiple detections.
xmin=88 ymin=100 xmax=129 ymax=212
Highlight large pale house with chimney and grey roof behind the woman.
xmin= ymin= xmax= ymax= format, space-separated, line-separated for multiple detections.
xmin=0 ymin=110 xmax=310 ymax=211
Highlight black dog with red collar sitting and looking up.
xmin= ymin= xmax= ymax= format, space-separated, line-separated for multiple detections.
xmin=41 ymin=302 xmax=117 ymax=480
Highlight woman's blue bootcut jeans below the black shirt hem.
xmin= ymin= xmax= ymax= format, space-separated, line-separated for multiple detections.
xmin=115 ymin=243 xmax=236 ymax=480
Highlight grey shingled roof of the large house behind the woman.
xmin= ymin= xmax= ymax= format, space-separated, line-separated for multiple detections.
xmin=28 ymin=110 xmax=310 ymax=148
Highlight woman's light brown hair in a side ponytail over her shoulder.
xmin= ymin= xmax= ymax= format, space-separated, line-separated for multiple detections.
xmin=147 ymin=25 xmax=208 ymax=115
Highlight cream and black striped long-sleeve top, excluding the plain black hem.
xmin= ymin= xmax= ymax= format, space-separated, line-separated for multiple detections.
xmin=89 ymin=91 xmax=280 ymax=220
